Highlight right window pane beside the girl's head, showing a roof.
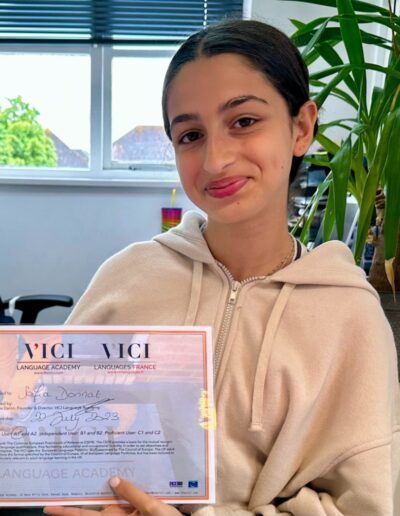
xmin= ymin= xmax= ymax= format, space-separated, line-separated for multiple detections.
xmin=106 ymin=49 xmax=174 ymax=168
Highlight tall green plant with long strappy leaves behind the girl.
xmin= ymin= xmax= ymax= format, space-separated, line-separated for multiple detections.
xmin=282 ymin=0 xmax=400 ymax=291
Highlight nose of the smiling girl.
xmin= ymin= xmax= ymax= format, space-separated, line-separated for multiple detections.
xmin=203 ymin=134 xmax=235 ymax=175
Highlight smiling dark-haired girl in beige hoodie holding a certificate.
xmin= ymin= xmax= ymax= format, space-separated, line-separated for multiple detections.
xmin=45 ymin=21 xmax=400 ymax=516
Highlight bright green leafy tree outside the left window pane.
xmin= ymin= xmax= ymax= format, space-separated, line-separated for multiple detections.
xmin=0 ymin=97 xmax=57 ymax=167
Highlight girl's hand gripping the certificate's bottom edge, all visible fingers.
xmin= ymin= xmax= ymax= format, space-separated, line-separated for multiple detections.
xmin=43 ymin=477 xmax=182 ymax=516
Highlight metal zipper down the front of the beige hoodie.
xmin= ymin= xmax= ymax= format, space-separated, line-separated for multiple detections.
xmin=214 ymin=262 xmax=266 ymax=379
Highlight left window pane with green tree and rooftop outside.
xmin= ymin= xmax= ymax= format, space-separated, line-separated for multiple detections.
xmin=0 ymin=49 xmax=90 ymax=169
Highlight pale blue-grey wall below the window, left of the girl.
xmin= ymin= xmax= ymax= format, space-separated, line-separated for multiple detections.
xmin=0 ymin=183 xmax=197 ymax=324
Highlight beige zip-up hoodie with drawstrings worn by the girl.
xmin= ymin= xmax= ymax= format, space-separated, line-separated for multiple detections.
xmin=68 ymin=212 xmax=400 ymax=516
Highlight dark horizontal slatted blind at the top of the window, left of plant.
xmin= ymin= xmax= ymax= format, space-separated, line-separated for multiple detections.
xmin=0 ymin=0 xmax=243 ymax=44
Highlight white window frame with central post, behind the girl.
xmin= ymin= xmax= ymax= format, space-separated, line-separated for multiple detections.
xmin=0 ymin=43 xmax=179 ymax=187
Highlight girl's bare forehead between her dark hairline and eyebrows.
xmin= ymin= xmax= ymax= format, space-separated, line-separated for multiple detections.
xmin=167 ymin=54 xmax=284 ymax=119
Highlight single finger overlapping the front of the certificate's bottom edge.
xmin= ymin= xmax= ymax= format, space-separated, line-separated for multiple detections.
xmin=108 ymin=477 xmax=182 ymax=516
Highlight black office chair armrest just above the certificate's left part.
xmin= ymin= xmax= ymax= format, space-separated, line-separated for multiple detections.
xmin=0 ymin=294 xmax=74 ymax=324
